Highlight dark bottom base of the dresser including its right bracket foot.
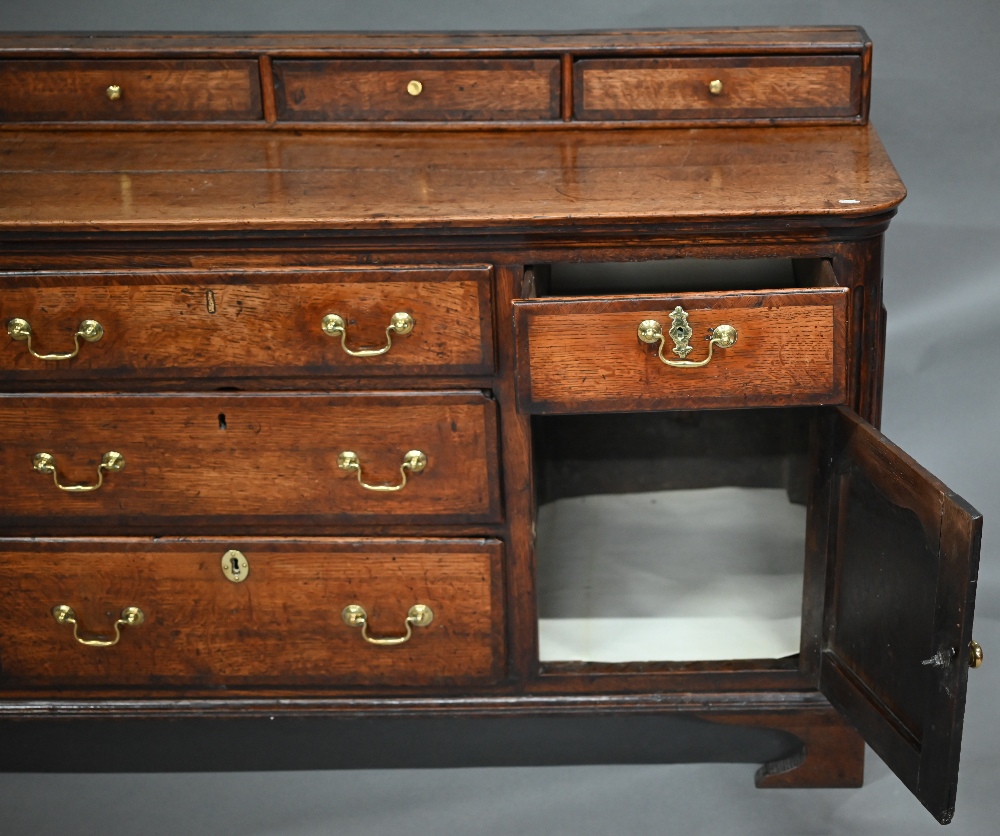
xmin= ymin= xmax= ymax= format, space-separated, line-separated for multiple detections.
xmin=0 ymin=703 xmax=864 ymax=787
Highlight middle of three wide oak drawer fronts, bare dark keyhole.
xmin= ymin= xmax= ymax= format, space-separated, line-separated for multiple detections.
xmin=0 ymin=392 xmax=500 ymax=534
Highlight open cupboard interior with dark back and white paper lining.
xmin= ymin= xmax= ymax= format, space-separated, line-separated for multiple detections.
xmin=532 ymin=409 xmax=812 ymax=666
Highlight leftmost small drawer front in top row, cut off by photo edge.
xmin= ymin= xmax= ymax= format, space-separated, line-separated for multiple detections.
xmin=0 ymin=59 xmax=263 ymax=122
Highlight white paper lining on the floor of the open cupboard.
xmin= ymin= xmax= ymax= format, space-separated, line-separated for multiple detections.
xmin=537 ymin=488 xmax=805 ymax=662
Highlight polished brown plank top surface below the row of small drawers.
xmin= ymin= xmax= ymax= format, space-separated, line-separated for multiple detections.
xmin=0 ymin=126 xmax=906 ymax=234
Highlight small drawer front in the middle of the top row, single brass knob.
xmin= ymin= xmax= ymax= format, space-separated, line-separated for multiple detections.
xmin=273 ymin=60 xmax=559 ymax=122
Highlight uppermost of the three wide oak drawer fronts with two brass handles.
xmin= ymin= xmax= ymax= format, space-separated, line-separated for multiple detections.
xmin=0 ymin=267 xmax=493 ymax=380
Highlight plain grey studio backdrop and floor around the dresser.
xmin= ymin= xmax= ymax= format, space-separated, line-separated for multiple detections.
xmin=0 ymin=0 xmax=1000 ymax=836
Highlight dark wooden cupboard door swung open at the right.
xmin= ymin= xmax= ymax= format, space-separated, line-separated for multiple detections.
xmin=813 ymin=409 xmax=982 ymax=824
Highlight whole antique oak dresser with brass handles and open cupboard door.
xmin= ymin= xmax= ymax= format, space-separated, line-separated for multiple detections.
xmin=0 ymin=27 xmax=982 ymax=822
